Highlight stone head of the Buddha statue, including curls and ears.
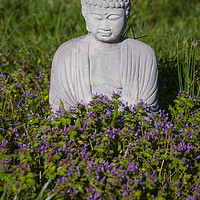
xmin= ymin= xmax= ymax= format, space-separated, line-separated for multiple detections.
xmin=81 ymin=0 xmax=131 ymax=43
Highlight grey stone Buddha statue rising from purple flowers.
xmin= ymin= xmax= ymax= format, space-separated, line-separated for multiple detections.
xmin=49 ymin=0 xmax=158 ymax=118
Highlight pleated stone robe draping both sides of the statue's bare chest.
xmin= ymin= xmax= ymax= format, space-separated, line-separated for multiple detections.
xmin=49 ymin=34 xmax=158 ymax=118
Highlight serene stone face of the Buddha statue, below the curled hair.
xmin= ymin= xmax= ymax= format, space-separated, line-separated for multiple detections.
xmin=86 ymin=6 xmax=127 ymax=43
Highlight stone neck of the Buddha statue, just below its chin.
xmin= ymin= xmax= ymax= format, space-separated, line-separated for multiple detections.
xmin=89 ymin=34 xmax=123 ymax=52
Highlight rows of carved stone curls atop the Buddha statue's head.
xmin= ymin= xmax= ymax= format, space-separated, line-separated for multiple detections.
xmin=82 ymin=0 xmax=130 ymax=9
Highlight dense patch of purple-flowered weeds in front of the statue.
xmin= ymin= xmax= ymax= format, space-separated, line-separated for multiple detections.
xmin=0 ymin=54 xmax=200 ymax=200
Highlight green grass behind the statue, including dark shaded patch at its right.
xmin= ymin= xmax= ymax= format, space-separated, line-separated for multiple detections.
xmin=0 ymin=0 xmax=200 ymax=108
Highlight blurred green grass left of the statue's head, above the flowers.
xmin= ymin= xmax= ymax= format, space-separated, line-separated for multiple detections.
xmin=0 ymin=0 xmax=84 ymax=53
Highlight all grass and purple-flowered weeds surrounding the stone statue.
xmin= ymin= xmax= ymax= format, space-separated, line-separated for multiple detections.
xmin=0 ymin=0 xmax=200 ymax=200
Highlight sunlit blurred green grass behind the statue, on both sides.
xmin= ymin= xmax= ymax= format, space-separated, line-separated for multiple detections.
xmin=0 ymin=0 xmax=200 ymax=57
